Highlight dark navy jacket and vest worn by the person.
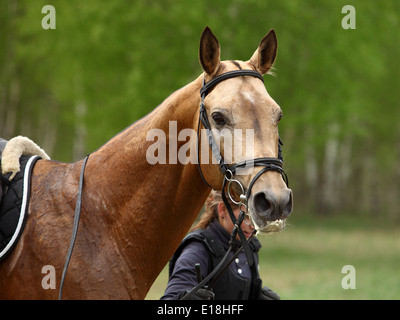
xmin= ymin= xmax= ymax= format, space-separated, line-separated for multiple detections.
xmin=161 ymin=220 xmax=261 ymax=300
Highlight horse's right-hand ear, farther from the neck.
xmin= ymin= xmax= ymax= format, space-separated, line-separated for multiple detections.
xmin=249 ymin=29 xmax=278 ymax=74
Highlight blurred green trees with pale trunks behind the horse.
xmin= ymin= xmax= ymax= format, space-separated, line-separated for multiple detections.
xmin=0 ymin=0 xmax=400 ymax=222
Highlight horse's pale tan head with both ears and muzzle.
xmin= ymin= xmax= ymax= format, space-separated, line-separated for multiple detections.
xmin=200 ymin=27 xmax=293 ymax=231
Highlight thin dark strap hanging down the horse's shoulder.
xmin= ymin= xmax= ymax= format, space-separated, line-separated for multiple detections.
xmin=58 ymin=154 xmax=90 ymax=300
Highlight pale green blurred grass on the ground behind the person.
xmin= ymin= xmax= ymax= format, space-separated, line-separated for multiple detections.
xmin=146 ymin=215 xmax=400 ymax=300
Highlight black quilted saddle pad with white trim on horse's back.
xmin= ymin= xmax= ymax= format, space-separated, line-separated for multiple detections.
xmin=0 ymin=156 xmax=41 ymax=261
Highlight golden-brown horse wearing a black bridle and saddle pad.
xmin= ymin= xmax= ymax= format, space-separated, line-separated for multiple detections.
xmin=0 ymin=27 xmax=293 ymax=299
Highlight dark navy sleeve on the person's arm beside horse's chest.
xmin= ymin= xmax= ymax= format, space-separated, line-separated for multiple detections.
xmin=161 ymin=240 xmax=209 ymax=300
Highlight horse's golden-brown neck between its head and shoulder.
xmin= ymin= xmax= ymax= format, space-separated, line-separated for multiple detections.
xmin=85 ymin=77 xmax=210 ymax=292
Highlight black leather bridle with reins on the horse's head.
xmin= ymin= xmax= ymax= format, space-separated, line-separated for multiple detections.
xmin=182 ymin=70 xmax=289 ymax=299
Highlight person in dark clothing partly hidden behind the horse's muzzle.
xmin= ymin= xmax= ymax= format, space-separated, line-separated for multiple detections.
xmin=161 ymin=190 xmax=280 ymax=300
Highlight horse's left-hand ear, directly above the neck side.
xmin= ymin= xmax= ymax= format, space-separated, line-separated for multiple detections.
xmin=199 ymin=27 xmax=221 ymax=76
